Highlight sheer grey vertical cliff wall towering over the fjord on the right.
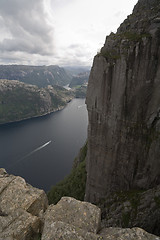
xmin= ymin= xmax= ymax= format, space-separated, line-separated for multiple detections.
xmin=86 ymin=0 xmax=160 ymax=202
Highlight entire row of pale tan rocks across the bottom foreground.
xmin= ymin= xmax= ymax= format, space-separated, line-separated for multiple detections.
xmin=0 ymin=169 xmax=160 ymax=240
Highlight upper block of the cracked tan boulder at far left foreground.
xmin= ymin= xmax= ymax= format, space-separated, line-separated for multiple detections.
xmin=0 ymin=169 xmax=48 ymax=216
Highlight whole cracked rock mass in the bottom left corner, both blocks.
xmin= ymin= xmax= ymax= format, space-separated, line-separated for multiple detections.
xmin=0 ymin=168 xmax=48 ymax=240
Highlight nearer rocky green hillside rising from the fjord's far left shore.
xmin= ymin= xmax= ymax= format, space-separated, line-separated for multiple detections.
xmin=0 ymin=79 xmax=73 ymax=124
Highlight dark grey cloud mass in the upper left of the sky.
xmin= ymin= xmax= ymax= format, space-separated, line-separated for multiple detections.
xmin=0 ymin=0 xmax=54 ymax=55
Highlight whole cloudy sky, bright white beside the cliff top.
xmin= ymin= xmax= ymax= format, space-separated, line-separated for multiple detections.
xmin=0 ymin=0 xmax=137 ymax=66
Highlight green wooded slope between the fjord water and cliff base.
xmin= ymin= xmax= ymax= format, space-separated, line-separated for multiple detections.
xmin=47 ymin=143 xmax=87 ymax=204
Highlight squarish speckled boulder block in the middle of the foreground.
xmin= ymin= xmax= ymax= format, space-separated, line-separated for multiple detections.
xmin=42 ymin=197 xmax=101 ymax=239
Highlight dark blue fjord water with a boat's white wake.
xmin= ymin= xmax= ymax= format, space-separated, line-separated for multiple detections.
xmin=0 ymin=99 xmax=88 ymax=191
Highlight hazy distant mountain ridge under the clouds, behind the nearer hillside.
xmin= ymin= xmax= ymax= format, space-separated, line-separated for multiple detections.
xmin=0 ymin=65 xmax=71 ymax=87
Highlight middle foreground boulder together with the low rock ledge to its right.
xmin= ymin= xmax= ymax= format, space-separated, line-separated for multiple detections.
xmin=42 ymin=197 xmax=160 ymax=240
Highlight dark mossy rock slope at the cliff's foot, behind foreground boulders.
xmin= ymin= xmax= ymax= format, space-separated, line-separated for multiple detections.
xmin=101 ymin=185 xmax=160 ymax=235
